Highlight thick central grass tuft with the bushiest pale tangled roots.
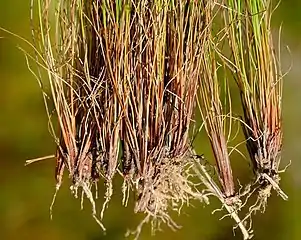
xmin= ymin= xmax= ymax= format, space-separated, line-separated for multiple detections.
xmin=121 ymin=1 xmax=205 ymax=234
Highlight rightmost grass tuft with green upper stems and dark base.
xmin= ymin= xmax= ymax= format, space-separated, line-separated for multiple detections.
xmin=224 ymin=0 xmax=288 ymax=218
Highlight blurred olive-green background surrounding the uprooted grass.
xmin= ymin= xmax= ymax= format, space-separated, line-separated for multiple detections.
xmin=0 ymin=0 xmax=301 ymax=240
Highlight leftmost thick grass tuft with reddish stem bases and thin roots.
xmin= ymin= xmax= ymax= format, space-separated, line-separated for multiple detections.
xmin=32 ymin=0 xmax=123 ymax=229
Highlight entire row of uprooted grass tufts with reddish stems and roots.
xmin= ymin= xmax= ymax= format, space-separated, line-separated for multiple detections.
xmin=27 ymin=0 xmax=287 ymax=239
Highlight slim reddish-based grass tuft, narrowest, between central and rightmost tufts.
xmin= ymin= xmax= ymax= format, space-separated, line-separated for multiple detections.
xmin=199 ymin=17 xmax=235 ymax=199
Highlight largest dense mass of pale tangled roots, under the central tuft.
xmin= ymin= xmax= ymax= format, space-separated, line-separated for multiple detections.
xmin=126 ymin=157 xmax=206 ymax=239
